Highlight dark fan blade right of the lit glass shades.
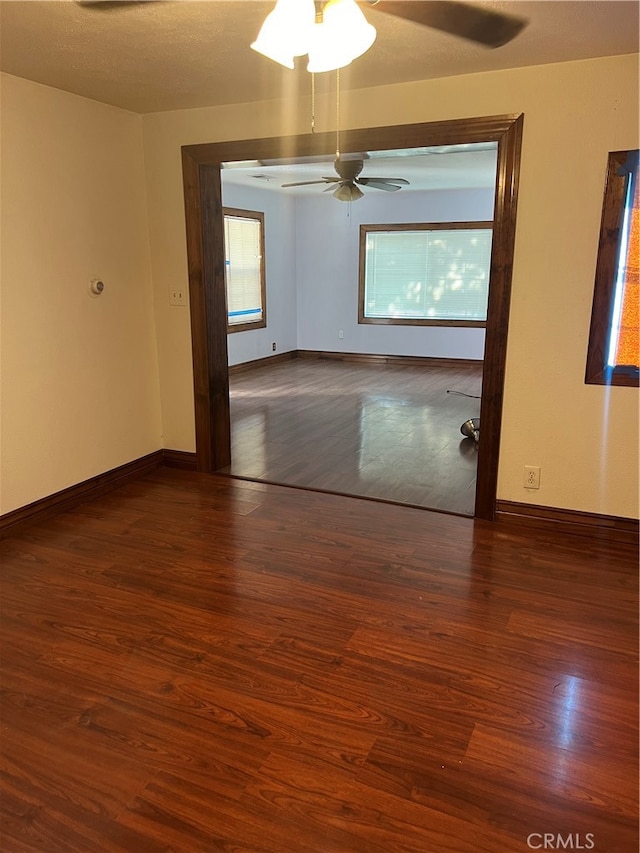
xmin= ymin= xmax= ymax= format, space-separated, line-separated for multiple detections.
xmin=368 ymin=0 xmax=528 ymax=47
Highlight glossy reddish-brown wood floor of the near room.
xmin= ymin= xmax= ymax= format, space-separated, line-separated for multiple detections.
xmin=0 ymin=469 xmax=638 ymax=853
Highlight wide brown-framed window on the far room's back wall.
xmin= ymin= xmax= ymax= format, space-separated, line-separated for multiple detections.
xmin=358 ymin=222 xmax=493 ymax=327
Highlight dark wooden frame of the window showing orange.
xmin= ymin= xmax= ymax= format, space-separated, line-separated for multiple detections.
xmin=584 ymin=149 xmax=640 ymax=388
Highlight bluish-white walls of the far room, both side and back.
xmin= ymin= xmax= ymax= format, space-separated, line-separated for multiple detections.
xmin=222 ymin=182 xmax=494 ymax=365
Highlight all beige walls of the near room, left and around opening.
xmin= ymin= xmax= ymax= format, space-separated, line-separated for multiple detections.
xmin=0 ymin=56 xmax=638 ymax=517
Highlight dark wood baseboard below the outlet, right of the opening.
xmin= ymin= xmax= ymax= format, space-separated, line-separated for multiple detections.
xmin=496 ymin=501 xmax=639 ymax=544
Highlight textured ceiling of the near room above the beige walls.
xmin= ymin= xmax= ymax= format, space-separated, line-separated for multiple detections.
xmin=0 ymin=0 xmax=639 ymax=113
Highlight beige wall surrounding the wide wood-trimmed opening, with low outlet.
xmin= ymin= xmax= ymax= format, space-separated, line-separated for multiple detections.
xmin=143 ymin=55 xmax=638 ymax=517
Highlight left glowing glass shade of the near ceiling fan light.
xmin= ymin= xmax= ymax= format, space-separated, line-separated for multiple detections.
xmin=251 ymin=0 xmax=316 ymax=68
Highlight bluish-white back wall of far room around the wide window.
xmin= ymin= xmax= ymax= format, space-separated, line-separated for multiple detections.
xmin=296 ymin=189 xmax=494 ymax=359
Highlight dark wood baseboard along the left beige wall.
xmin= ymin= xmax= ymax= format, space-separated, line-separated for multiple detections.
xmin=0 ymin=450 xmax=164 ymax=539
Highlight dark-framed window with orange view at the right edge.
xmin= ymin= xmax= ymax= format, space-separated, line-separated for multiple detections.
xmin=585 ymin=150 xmax=640 ymax=386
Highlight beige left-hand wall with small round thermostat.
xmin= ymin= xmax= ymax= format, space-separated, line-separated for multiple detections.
xmin=0 ymin=75 xmax=162 ymax=512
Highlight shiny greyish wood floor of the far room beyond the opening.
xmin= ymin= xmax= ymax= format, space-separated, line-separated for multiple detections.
xmin=226 ymin=359 xmax=482 ymax=515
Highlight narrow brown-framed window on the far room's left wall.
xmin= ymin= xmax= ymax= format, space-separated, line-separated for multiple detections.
xmin=223 ymin=207 xmax=267 ymax=332
